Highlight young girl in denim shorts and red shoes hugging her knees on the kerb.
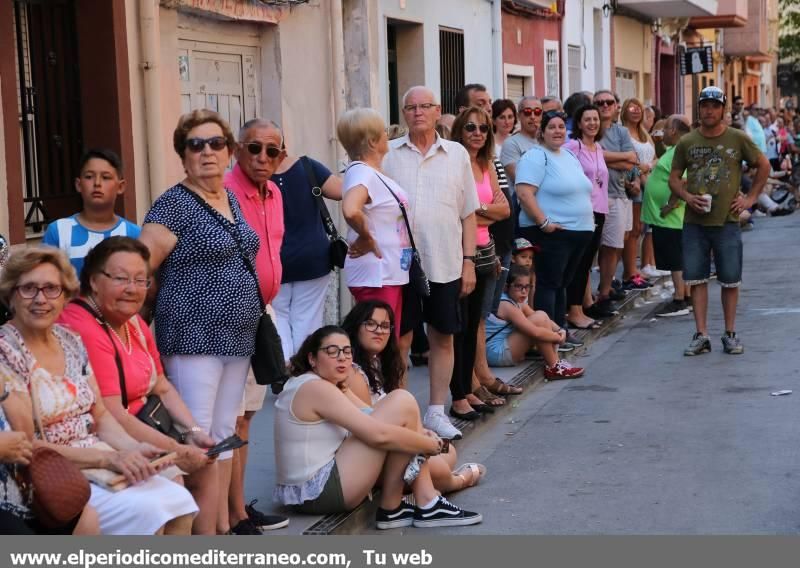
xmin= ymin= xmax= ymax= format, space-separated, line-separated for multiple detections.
xmin=486 ymin=264 xmax=583 ymax=380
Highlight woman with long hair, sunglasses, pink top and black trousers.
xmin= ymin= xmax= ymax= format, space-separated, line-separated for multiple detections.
xmin=450 ymin=107 xmax=511 ymax=420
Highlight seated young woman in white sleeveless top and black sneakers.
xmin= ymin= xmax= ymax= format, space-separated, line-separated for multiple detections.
xmin=274 ymin=323 xmax=482 ymax=529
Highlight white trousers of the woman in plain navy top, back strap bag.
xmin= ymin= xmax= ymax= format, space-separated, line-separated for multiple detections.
xmin=272 ymin=273 xmax=331 ymax=360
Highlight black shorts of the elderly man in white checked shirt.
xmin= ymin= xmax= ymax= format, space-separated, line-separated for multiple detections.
xmin=400 ymin=278 xmax=461 ymax=335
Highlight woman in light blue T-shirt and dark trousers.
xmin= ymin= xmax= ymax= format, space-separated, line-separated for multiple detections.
xmin=516 ymin=111 xmax=594 ymax=345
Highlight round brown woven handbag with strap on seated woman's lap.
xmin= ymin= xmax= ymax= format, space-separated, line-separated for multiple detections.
xmin=18 ymin=377 xmax=91 ymax=529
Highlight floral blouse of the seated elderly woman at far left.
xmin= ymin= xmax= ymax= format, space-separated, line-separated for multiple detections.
xmin=0 ymin=324 xmax=99 ymax=448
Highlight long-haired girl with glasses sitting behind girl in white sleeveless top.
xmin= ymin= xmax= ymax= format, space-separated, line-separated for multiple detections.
xmin=342 ymin=300 xmax=486 ymax=493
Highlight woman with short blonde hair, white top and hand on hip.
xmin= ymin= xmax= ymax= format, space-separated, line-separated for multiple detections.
xmin=336 ymin=108 xmax=412 ymax=338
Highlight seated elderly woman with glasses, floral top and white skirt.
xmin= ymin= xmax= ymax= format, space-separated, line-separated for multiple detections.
xmin=0 ymin=247 xmax=197 ymax=535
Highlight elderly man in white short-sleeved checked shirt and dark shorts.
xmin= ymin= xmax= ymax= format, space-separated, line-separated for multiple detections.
xmin=383 ymin=86 xmax=480 ymax=439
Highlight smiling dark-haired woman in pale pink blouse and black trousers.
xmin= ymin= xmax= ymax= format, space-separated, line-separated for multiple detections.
xmin=564 ymin=105 xmax=608 ymax=329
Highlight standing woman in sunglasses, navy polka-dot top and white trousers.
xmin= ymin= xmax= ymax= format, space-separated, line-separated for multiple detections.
xmin=140 ymin=110 xmax=262 ymax=534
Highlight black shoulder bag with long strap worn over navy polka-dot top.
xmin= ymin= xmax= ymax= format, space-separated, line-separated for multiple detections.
xmin=183 ymin=190 xmax=290 ymax=394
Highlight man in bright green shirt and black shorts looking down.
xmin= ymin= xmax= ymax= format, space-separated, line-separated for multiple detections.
xmin=642 ymin=114 xmax=692 ymax=317
